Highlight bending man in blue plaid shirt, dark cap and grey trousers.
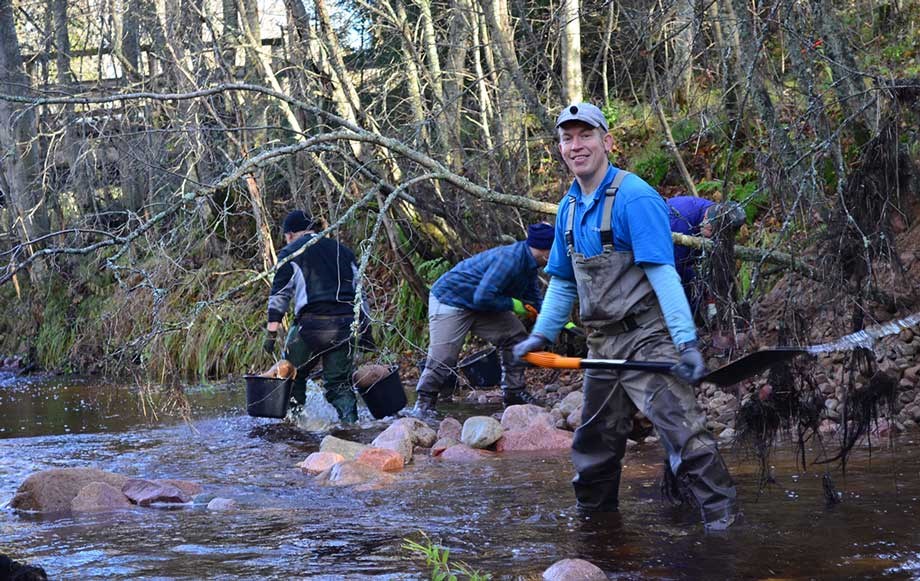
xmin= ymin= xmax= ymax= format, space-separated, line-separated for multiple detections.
xmin=413 ymin=222 xmax=554 ymax=416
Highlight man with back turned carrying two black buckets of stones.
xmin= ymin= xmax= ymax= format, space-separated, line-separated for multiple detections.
xmin=263 ymin=210 xmax=358 ymax=422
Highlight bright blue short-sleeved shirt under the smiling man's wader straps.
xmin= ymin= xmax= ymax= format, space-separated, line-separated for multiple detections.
xmin=546 ymin=165 xmax=674 ymax=280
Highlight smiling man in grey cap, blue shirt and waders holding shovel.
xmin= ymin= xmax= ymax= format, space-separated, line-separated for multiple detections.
xmin=513 ymin=103 xmax=737 ymax=530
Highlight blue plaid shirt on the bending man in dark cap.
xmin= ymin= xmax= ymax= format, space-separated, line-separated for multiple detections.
xmin=431 ymin=241 xmax=542 ymax=311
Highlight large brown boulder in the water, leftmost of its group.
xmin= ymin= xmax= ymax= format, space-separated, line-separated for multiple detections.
xmin=10 ymin=468 xmax=128 ymax=512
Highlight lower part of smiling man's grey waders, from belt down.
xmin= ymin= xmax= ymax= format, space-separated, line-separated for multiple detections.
xmin=572 ymin=320 xmax=735 ymax=521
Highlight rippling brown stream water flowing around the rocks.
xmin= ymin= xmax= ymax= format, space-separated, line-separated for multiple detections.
xmin=0 ymin=370 xmax=920 ymax=580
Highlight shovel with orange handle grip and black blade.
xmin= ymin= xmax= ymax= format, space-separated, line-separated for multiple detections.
xmin=524 ymin=347 xmax=808 ymax=387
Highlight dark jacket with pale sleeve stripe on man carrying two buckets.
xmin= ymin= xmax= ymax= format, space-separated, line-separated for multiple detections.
xmin=268 ymin=234 xmax=358 ymax=322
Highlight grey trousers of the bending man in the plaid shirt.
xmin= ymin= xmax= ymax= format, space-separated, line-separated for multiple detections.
xmin=415 ymin=294 xmax=527 ymax=394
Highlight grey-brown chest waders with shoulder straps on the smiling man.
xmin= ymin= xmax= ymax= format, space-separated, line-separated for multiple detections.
xmin=565 ymin=170 xmax=736 ymax=523
